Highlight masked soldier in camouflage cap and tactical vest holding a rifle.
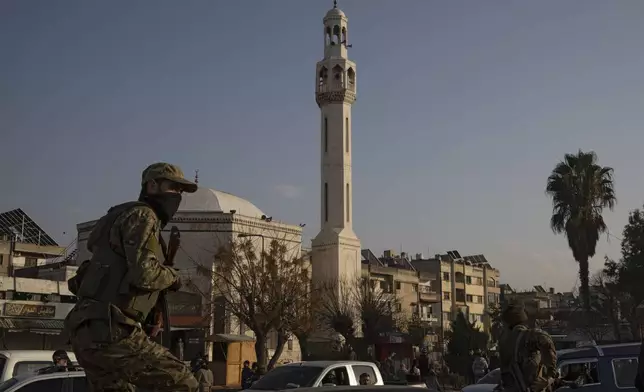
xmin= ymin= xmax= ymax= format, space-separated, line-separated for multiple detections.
xmin=65 ymin=163 xmax=199 ymax=392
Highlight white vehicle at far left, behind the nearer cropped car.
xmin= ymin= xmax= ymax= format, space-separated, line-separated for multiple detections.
xmin=0 ymin=350 xmax=76 ymax=381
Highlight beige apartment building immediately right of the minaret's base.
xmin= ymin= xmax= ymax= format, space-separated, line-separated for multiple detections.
xmin=362 ymin=249 xmax=440 ymax=331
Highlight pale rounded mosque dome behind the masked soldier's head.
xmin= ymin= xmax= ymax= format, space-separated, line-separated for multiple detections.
xmin=179 ymin=187 xmax=264 ymax=218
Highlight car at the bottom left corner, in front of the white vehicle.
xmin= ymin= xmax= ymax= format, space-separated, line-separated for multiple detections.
xmin=0 ymin=371 xmax=90 ymax=392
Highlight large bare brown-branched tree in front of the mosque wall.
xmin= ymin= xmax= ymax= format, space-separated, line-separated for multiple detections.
xmin=196 ymin=238 xmax=310 ymax=369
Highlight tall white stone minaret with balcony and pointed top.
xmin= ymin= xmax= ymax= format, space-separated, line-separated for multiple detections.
xmin=311 ymin=1 xmax=361 ymax=283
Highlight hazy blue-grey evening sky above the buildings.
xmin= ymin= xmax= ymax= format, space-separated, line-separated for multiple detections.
xmin=0 ymin=0 xmax=644 ymax=290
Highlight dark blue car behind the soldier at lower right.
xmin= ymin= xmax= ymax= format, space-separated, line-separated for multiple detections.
xmin=463 ymin=343 xmax=640 ymax=392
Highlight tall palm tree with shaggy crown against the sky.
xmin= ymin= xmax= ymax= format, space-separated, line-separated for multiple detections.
xmin=546 ymin=150 xmax=617 ymax=312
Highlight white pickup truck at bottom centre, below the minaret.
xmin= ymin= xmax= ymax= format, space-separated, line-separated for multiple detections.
xmin=248 ymin=361 xmax=384 ymax=391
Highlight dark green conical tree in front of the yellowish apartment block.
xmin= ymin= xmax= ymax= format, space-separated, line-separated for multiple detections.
xmin=445 ymin=312 xmax=489 ymax=376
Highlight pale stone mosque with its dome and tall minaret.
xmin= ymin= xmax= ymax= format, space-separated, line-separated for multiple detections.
xmin=77 ymin=2 xmax=361 ymax=361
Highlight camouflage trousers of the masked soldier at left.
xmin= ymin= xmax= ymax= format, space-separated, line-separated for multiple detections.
xmin=70 ymin=320 xmax=199 ymax=392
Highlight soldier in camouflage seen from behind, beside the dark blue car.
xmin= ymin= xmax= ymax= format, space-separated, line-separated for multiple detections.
xmin=499 ymin=304 xmax=558 ymax=392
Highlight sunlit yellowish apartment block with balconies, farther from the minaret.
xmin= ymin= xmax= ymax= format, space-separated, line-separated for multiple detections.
xmin=411 ymin=251 xmax=501 ymax=331
